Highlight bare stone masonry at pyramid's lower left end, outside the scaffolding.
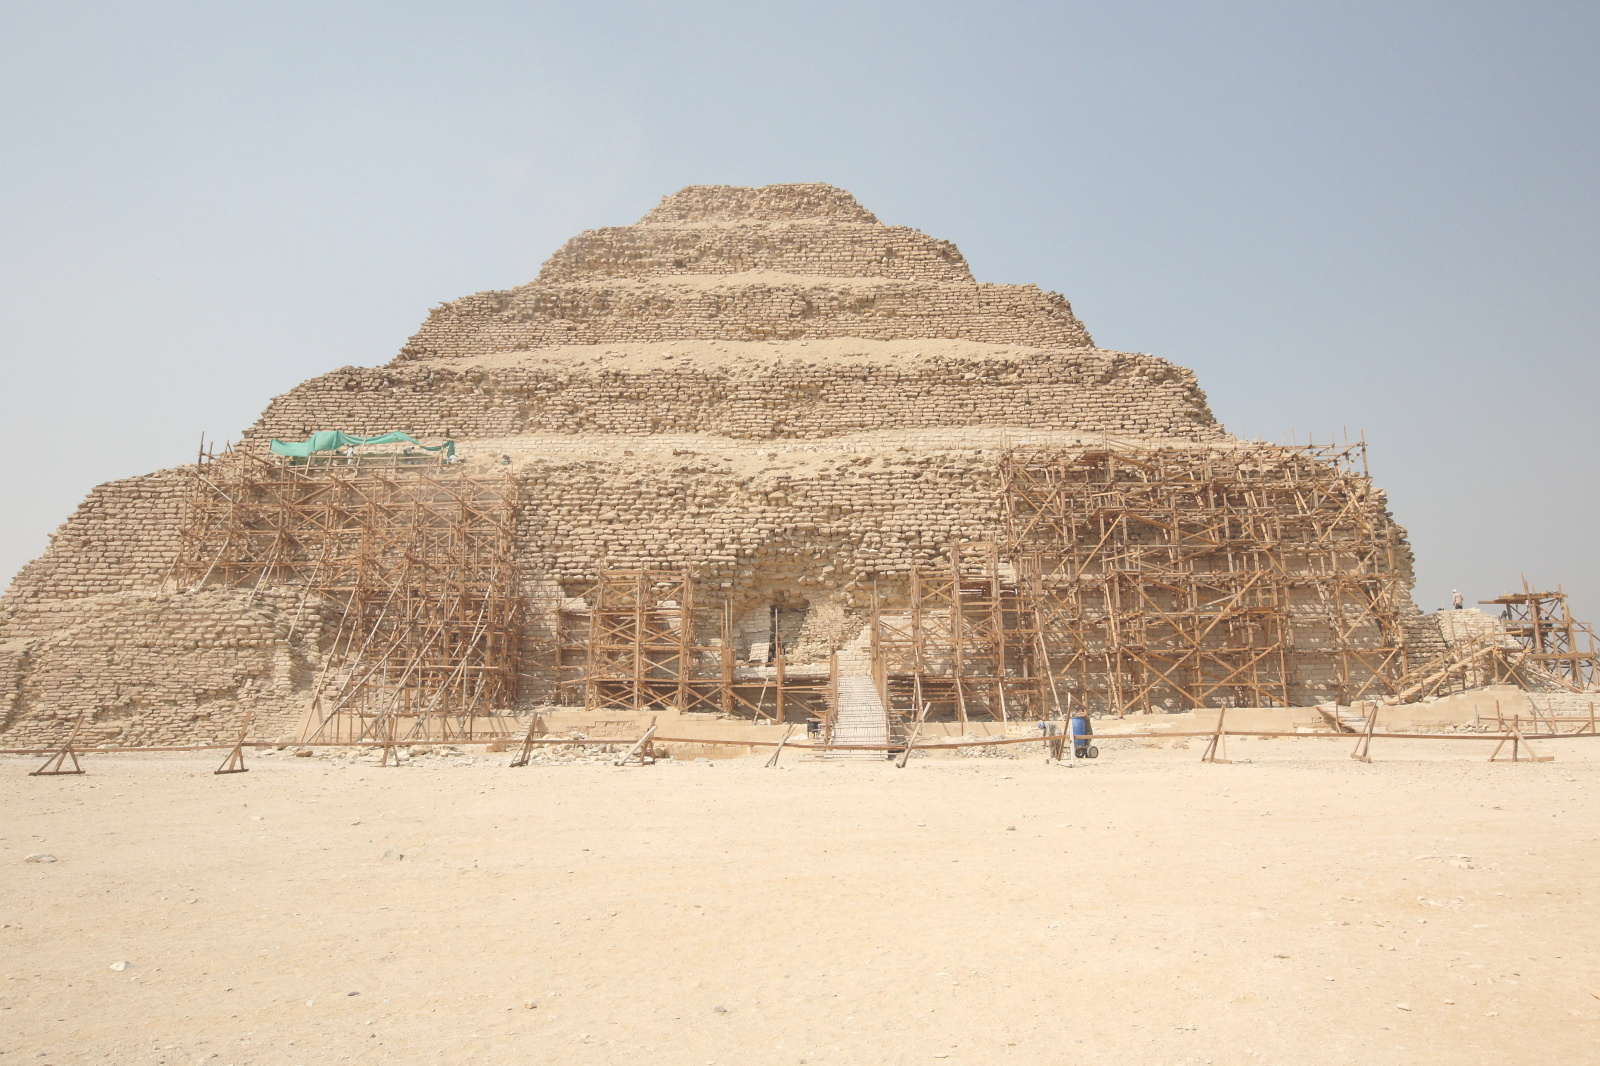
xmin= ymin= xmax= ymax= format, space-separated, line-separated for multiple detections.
xmin=0 ymin=469 xmax=322 ymax=747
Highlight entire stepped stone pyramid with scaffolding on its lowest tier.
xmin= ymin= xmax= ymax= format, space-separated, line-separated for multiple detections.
xmin=0 ymin=184 xmax=1437 ymax=744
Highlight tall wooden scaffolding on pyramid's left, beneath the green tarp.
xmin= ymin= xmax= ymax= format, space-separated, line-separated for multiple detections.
xmin=174 ymin=451 xmax=522 ymax=743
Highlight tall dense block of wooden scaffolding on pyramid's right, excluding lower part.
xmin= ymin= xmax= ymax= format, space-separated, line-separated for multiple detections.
xmin=1000 ymin=443 xmax=1406 ymax=714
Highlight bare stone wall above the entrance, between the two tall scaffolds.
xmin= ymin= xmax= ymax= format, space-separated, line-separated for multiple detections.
xmin=517 ymin=451 xmax=1000 ymax=587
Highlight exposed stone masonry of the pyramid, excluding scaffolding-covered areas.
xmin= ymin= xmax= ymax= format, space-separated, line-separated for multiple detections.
xmin=0 ymin=184 xmax=1410 ymax=743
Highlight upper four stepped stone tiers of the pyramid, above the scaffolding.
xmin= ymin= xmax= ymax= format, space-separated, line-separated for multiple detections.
xmin=246 ymin=184 xmax=1203 ymax=442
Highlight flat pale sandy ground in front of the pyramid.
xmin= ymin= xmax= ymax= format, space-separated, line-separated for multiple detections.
xmin=0 ymin=739 xmax=1600 ymax=1066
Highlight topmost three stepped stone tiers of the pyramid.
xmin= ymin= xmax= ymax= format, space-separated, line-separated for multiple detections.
xmin=400 ymin=186 xmax=1093 ymax=359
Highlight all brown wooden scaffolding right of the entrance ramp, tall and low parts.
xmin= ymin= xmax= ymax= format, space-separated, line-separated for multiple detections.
xmin=872 ymin=443 xmax=1406 ymax=723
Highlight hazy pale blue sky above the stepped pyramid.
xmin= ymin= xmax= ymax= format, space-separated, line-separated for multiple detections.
xmin=0 ymin=0 xmax=1600 ymax=623
